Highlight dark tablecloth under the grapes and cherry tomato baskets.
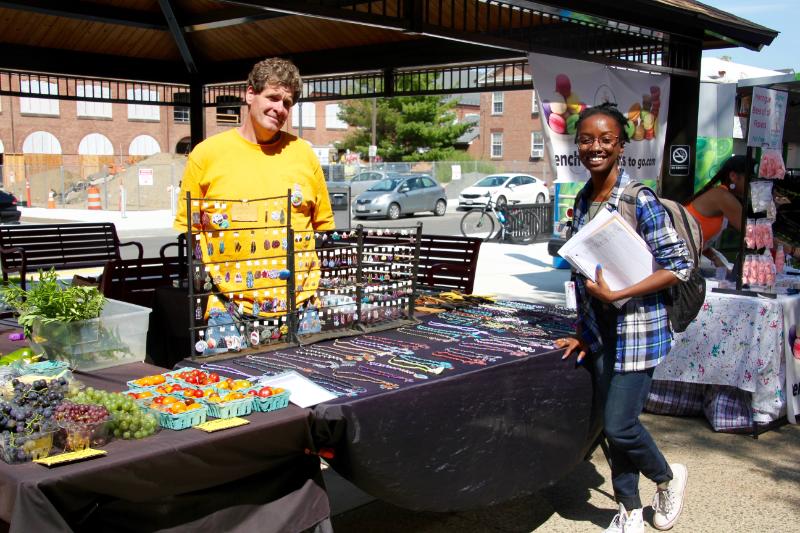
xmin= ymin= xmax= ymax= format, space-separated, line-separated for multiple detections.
xmin=0 ymin=364 xmax=330 ymax=532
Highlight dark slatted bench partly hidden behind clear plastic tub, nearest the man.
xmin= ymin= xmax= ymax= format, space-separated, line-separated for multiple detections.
xmin=100 ymin=256 xmax=188 ymax=307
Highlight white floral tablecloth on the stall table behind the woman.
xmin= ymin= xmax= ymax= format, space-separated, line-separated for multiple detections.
xmin=653 ymin=292 xmax=800 ymax=421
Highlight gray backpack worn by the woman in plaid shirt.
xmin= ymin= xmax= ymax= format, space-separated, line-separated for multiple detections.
xmin=617 ymin=182 xmax=706 ymax=332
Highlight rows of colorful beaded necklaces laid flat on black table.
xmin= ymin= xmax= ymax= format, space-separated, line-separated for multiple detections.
xmin=180 ymin=301 xmax=575 ymax=401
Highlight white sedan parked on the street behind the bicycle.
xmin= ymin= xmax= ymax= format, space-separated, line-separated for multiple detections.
xmin=458 ymin=174 xmax=550 ymax=209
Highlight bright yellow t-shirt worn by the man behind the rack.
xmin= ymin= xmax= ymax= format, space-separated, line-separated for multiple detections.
xmin=174 ymin=129 xmax=335 ymax=315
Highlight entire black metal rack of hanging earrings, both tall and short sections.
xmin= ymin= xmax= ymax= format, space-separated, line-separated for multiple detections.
xmin=186 ymin=190 xmax=422 ymax=361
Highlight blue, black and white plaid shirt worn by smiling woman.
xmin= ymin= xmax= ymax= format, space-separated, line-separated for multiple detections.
xmin=572 ymin=170 xmax=694 ymax=372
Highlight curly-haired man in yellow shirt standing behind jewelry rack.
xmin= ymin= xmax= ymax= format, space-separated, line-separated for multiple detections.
xmin=174 ymin=58 xmax=335 ymax=351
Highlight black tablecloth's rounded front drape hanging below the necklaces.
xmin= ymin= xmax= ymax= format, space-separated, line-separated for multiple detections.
xmin=314 ymin=351 xmax=600 ymax=511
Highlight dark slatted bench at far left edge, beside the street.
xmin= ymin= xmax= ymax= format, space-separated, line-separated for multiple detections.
xmin=0 ymin=222 xmax=143 ymax=289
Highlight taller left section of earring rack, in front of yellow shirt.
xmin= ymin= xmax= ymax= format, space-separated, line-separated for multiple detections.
xmin=186 ymin=191 xmax=302 ymax=357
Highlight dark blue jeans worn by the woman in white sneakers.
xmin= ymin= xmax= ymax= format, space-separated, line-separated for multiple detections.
xmin=593 ymin=335 xmax=672 ymax=509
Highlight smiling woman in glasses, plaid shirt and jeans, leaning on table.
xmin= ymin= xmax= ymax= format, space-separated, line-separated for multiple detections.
xmin=556 ymin=104 xmax=693 ymax=533
